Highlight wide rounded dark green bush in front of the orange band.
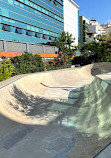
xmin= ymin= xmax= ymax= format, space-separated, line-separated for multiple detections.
xmin=11 ymin=52 xmax=44 ymax=74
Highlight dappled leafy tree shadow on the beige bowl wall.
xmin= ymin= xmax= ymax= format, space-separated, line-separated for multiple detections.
xmin=10 ymin=86 xmax=60 ymax=117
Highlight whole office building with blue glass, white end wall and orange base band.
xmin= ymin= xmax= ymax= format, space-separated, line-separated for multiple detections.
xmin=0 ymin=0 xmax=78 ymax=58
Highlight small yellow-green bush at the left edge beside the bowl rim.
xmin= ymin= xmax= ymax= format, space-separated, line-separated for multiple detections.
xmin=0 ymin=59 xmax=15 ymax=81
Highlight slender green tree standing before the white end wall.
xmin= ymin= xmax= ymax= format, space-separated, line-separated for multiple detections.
xmin=54 ymin=31 xmax=75 ymax=65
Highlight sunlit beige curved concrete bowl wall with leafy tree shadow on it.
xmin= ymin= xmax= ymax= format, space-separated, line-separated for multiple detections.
xmin=0 ymin=65 xmax=94 ymax=125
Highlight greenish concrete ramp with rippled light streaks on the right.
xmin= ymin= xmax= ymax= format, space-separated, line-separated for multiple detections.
xmin=68 ymin=77 xmax=111 ymax=138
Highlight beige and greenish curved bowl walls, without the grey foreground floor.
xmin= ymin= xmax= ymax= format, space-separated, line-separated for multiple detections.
xmin=0 ymin=63 xmax=111 ymax=137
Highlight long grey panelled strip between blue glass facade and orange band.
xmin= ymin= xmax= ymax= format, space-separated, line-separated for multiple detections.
xmin=0 ymin=40 xmax=58 ymax=54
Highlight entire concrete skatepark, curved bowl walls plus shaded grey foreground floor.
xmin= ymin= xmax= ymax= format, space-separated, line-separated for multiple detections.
xmin=0 ymin=63 xmax=111 ymax=158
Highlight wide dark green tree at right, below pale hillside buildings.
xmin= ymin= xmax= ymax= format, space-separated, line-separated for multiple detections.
xmin=80 ymin=36 xmax=111 ymax=63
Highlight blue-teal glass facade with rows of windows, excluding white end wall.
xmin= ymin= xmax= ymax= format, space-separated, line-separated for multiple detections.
xmin=0 ymin=0 xmax=64 ymax=44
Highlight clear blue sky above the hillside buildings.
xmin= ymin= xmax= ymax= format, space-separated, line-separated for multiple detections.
xmin=74 ymin=0 xmax=111 ymax=24
